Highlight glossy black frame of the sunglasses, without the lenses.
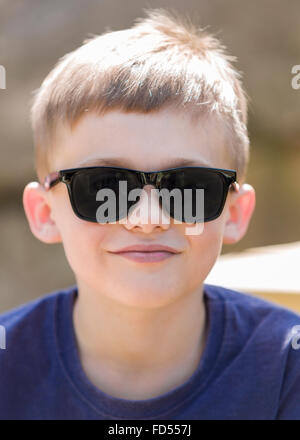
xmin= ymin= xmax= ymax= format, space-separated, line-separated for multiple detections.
xmin=43 ymin=166 xmax=238 ymax=223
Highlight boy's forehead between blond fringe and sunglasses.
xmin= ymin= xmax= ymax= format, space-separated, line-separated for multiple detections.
xmin=50 ymin=109 xmax=230 ymax=171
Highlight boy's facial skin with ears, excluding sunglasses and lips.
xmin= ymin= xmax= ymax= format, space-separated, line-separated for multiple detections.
xmin=23 ymin=109 xmax=255 ymax=308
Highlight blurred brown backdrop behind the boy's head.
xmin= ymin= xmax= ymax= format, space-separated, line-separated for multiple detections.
xmin=0 ymin=0 xmax=300 ymax=312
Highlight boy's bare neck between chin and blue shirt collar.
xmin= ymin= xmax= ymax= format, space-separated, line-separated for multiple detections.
xmin=73 ymin=283 xmax=207 ymax=398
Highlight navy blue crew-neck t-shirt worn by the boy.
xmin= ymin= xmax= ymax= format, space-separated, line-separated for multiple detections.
xmin=0 ymin=284 xmax=300 ymax=420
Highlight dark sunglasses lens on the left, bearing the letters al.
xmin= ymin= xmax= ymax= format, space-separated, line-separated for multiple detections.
xmin=71 ymin=168 xmax=139 ymax=223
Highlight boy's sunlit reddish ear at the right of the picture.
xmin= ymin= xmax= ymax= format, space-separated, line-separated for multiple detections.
xmin=223 ymin=183 xmax=255 ymax=244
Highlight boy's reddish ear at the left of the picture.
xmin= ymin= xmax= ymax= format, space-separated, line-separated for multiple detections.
xmin=23 ymin=182 xmax=62 ymax=243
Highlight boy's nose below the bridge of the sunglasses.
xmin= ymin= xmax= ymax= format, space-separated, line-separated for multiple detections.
xmin=120 ymin=185 xmax=170 ymax=234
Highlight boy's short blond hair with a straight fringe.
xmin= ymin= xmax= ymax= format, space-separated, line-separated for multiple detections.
xmin=31 ymin=9 xmax=249 ymax=181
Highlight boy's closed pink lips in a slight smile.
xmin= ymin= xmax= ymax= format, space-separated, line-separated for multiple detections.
xmin=111 ymin=245 xmax=181 ymax=263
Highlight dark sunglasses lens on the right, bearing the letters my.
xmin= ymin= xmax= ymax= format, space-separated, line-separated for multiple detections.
xmin=160 ymin=168 xmax=227 ymax=223
